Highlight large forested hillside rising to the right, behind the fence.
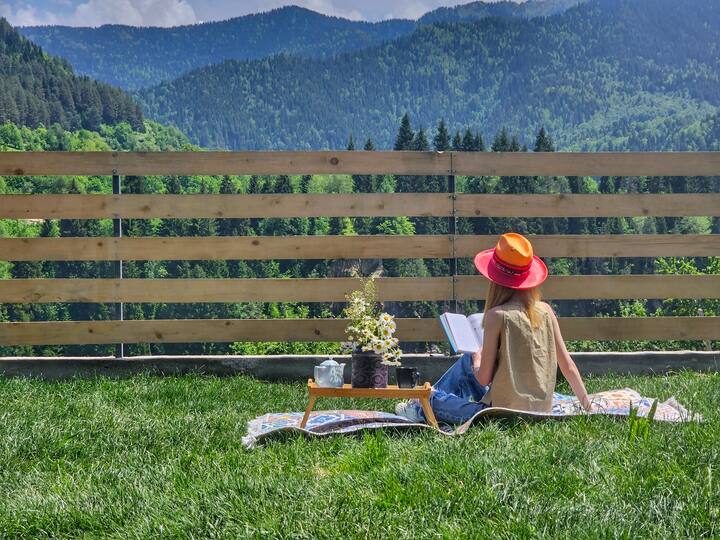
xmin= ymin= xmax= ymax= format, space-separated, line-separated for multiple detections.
xmin=138 ymin=0 xmax=720 ymax=150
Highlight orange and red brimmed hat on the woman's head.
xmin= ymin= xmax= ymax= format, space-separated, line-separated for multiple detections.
xmin=474 ymin=233 xmax=547 ymax=290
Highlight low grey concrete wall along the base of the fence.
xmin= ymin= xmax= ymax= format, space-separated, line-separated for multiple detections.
xmin=0 ymin=351 xmax=720 ymax=382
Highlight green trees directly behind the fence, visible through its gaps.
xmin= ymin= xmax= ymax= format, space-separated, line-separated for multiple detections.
xmin=0 ymin=114 xmax=720 ymax=354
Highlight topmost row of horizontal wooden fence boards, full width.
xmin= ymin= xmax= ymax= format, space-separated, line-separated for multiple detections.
xmin=0 ymin=151 xmax=720 ymax=176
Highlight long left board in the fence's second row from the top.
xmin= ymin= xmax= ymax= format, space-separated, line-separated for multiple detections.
xmin=0 ymin=193 xmax=452 ymax=219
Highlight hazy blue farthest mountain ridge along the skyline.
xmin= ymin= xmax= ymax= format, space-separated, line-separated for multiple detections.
xmin=21 ymin=0 xmax=580 ymax=90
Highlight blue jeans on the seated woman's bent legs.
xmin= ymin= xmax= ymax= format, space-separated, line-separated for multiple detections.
xmin=416 ymin=353 xmax=490 ymax=424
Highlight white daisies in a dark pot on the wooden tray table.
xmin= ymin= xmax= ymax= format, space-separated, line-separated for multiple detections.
xmin=343 ymin=268 xmax=402 ymax=388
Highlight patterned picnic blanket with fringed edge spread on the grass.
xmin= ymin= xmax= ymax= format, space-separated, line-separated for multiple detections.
xmin=242 ymin=388 xmax=702 ymax=448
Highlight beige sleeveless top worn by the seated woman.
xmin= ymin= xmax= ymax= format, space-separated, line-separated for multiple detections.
xmin=481 ymin=300 xmax=557 ymax=412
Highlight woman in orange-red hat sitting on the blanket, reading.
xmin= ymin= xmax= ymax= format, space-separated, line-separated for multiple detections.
xmin=396 ymin=233 xmax=590 ymax=424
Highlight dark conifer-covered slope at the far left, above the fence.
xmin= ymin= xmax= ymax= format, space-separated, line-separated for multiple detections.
xmin=0 ymin=18 xmax=143 ymax=129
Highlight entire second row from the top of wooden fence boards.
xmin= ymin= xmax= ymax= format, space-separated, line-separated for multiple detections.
xmin=0 ymin=193 xmax=720 ymax=219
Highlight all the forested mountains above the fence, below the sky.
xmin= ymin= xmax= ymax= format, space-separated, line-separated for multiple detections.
xmin=5 ymin=0 xmax=720 ymax=150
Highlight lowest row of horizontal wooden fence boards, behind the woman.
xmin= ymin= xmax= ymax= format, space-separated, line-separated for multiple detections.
xmin=0 ymin=317 xmax=720 ymax=345
